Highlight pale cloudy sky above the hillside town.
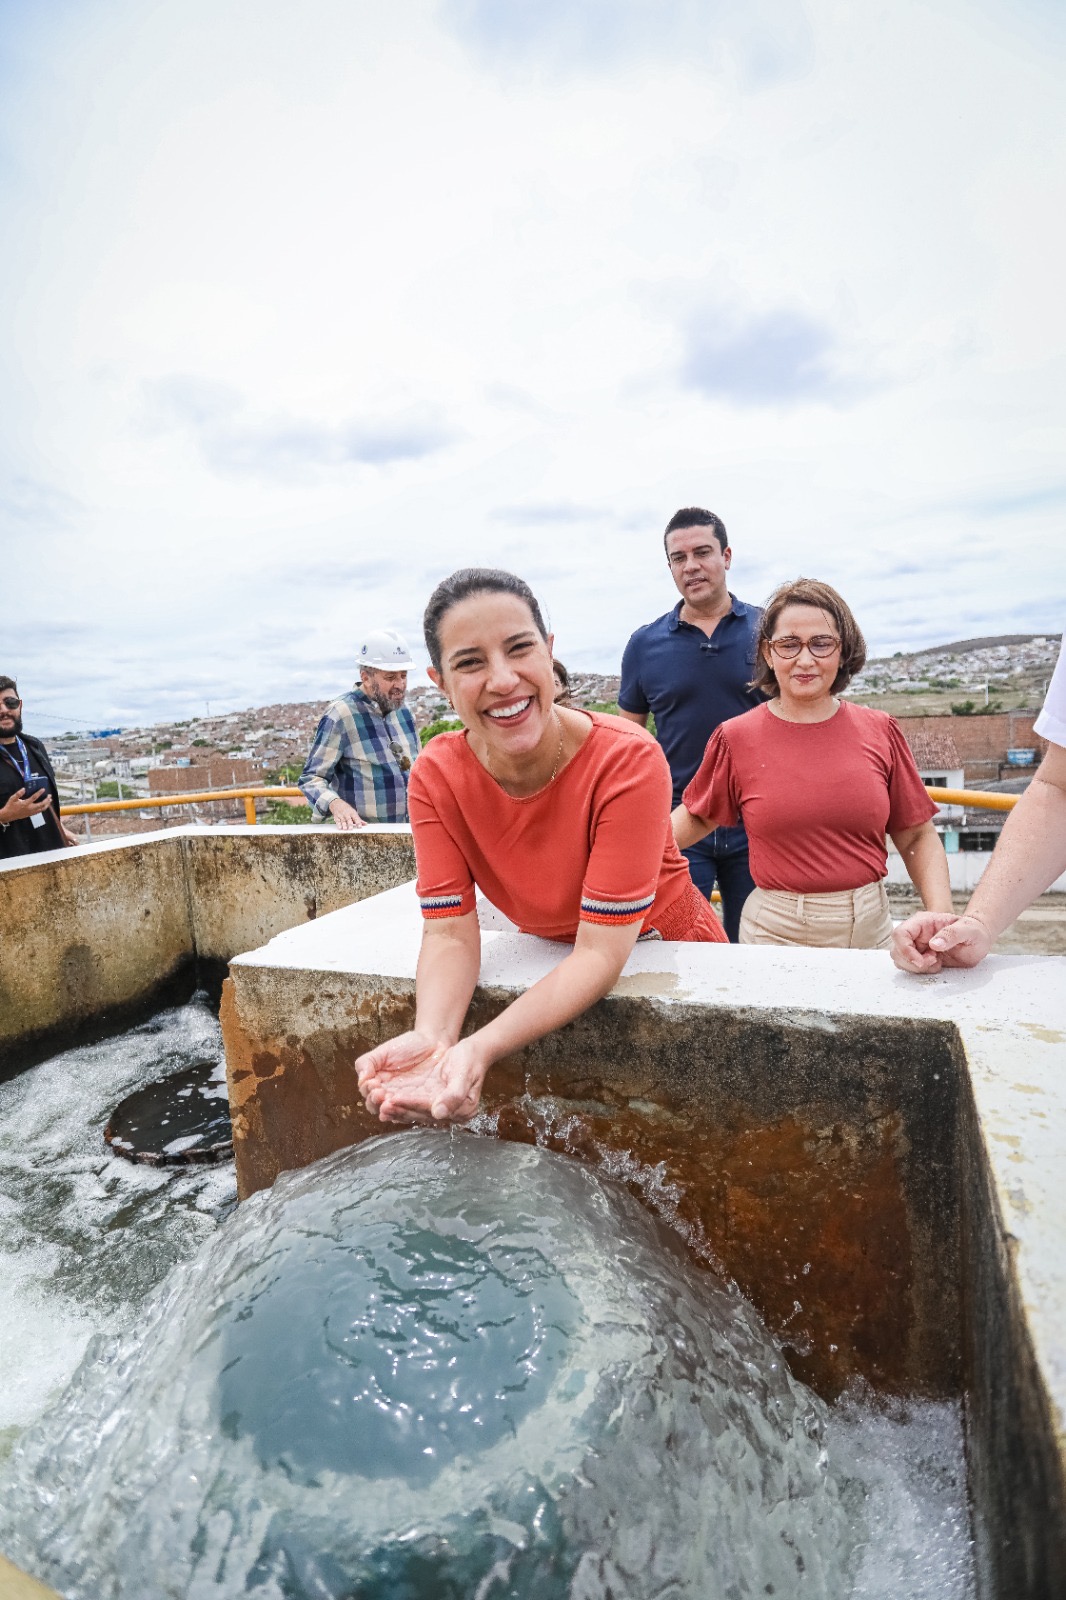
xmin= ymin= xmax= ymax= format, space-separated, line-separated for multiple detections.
xmin=0 ymin=0 xmax=1066 ymax=733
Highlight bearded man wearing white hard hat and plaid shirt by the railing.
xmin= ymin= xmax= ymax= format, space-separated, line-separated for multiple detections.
xmin=299 ymin=627 xmax=419 ymax=832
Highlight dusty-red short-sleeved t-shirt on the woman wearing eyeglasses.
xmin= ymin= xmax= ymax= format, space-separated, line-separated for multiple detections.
xmin=683 ymin=701 xmax=936 ymax=894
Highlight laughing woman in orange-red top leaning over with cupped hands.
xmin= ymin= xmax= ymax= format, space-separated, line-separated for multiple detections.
xmin=357 ymin=568 xmax=725 ymax=1122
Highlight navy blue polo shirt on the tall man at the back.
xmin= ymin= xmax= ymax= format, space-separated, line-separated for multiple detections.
xmin=618 ymin=595 xmax=765 ymax=806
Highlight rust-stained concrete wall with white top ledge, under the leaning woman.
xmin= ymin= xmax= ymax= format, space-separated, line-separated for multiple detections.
xmin=222 ymin=890 xmax=1066 ymax=1600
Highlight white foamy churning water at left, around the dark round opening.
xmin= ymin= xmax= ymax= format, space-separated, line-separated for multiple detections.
xmin=0 ymin=997 xmax=237 ymax=1454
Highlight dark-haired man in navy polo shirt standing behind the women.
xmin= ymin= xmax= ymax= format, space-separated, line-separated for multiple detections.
xmin=618 ymin=506 xmax=763 ymax=944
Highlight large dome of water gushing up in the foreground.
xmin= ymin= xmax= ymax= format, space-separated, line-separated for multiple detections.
xmin=0 ymin=1131 xmax=967 ymax=1600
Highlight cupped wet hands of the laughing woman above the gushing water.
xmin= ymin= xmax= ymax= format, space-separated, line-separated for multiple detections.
xmin=355 ymin=1029 xmax=488 ymax=1123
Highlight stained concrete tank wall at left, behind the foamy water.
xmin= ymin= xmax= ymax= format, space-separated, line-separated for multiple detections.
xmin=0 ymin=827 xmax=415 ymax=1074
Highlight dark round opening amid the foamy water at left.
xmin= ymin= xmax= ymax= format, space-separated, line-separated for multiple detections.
xmin=104 ymin=1061 xmax=234 ymax=1166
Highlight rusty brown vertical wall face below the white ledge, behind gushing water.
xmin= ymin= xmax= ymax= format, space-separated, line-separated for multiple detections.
xmin=222 ymin=962 xmax=960 ymax=1397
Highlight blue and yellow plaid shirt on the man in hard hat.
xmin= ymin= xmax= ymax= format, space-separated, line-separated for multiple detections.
xmin=299 ymin=688 xmax=421 ymax=822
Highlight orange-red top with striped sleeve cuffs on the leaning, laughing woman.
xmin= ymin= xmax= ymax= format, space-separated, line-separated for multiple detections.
xmin=408 ymin=712 xmax=725 ymax=941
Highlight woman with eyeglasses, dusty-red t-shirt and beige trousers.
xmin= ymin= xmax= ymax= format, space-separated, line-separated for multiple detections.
xmin=672 ymin=578 xmax=951 ymax=950
